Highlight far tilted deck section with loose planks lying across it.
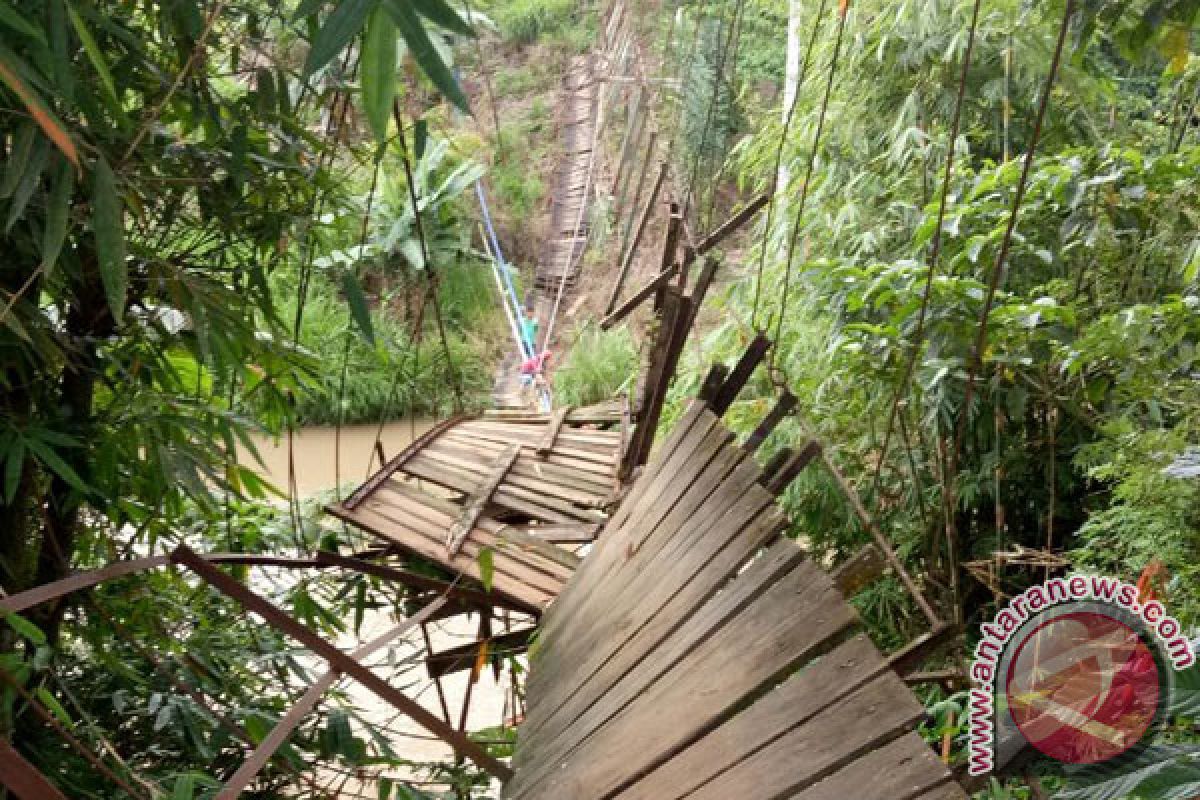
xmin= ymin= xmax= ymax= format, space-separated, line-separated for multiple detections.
xmin=328 ymin=403 xmax=624 ymax=614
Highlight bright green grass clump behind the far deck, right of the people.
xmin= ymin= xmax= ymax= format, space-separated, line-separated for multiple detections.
xmin=554 ymin=325 xmax=637 ymax=405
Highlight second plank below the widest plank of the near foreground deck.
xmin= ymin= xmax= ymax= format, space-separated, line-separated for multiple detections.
xmin=691 ymin=673 xmax=924 ymax=800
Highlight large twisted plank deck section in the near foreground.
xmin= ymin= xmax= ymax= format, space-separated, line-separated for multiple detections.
xmin=504 ymin=401 xmax=966 ymax=800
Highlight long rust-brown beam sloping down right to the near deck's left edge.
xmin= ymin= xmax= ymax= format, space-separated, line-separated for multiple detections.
xmin=170 ymin=545 xmax=512 ymax=781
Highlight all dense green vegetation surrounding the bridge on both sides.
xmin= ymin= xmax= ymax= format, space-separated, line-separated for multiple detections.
xmin=0 ymin=0 xmax=1200 ymax=800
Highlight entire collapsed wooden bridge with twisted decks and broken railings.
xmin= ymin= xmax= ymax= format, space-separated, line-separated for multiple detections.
xmin=0 ymin=5 xmax=966 ymax=800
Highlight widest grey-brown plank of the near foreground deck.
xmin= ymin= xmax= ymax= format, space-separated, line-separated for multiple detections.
xmin=510 ymin=551 xmax=856 ymax=800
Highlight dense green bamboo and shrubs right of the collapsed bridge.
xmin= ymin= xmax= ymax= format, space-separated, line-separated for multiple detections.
xmin=660 ymin=0 xmax=1200 ymax=798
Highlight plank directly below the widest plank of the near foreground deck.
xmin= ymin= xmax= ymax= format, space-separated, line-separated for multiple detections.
xmin=618 ymin=636 xmax=888 ymax=800
